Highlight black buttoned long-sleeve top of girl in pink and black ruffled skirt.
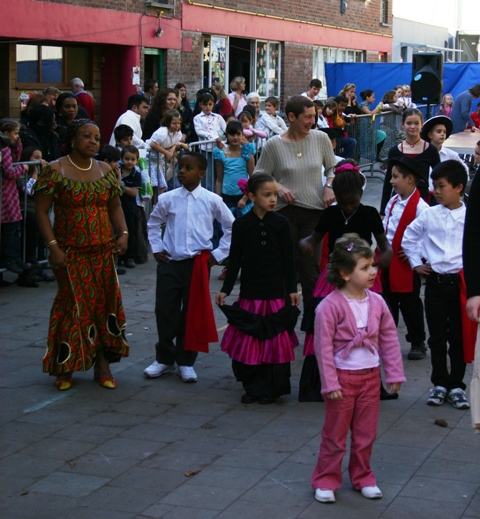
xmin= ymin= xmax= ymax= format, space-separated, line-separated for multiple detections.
xmin=221 ymin=211 xmax=297 ymax=299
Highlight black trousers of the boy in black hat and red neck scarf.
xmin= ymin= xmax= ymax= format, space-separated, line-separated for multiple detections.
xmin=382 ymin=271 xmax=425 ymax=346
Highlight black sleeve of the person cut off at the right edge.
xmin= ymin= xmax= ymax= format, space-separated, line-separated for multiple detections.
xmin=463 ymin=167 xmax=480 ymax=297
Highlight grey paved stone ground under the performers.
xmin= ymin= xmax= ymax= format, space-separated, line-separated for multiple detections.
xmin=0 ymin=173 xmax=480 ymax=519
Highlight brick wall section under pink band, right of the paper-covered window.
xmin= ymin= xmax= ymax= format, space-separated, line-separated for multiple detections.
xmin=280 ymin=43 xmax=313 ymax=109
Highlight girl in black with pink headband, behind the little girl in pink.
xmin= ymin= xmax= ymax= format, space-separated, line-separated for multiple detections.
xmin=298 ymin=159 xmax=392 ymax=402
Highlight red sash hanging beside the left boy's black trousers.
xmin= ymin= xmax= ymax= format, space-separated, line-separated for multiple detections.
xmin=183 ymin=250 xmax=218 ymax=353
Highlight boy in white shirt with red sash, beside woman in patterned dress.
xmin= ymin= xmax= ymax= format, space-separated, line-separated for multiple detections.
xmin=144 ymin=151 xmax=234 ymax=382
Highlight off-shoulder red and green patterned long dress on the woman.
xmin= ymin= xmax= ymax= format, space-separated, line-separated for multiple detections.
xmin=35 ymin=167 xmax=129 ymax=376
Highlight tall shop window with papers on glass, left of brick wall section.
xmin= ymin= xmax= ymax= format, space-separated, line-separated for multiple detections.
xmin=255 ymin=40 xmax=280 ymax=97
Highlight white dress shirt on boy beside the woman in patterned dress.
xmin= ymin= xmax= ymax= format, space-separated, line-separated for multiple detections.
xmin=147 ymin=186 xmax=234 ymax=262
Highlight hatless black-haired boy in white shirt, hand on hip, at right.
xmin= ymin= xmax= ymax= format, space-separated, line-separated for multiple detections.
xmin=402 ymin=160 xmax=470 ymax=409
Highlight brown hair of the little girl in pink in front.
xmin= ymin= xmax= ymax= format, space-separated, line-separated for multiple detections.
xmin=327 ymin=232 xmax=373 ymax=288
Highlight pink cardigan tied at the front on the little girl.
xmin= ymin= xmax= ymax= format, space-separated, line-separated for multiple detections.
xmin=314 ymin=289 xmax=406 ymax=394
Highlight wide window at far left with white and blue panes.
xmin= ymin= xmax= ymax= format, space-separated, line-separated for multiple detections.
xmin=16 ymin=45 xmax=91 ymax=86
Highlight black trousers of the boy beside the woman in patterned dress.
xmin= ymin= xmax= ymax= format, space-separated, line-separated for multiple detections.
xmin=155 ymin=258 xmax=198 ymax=366
